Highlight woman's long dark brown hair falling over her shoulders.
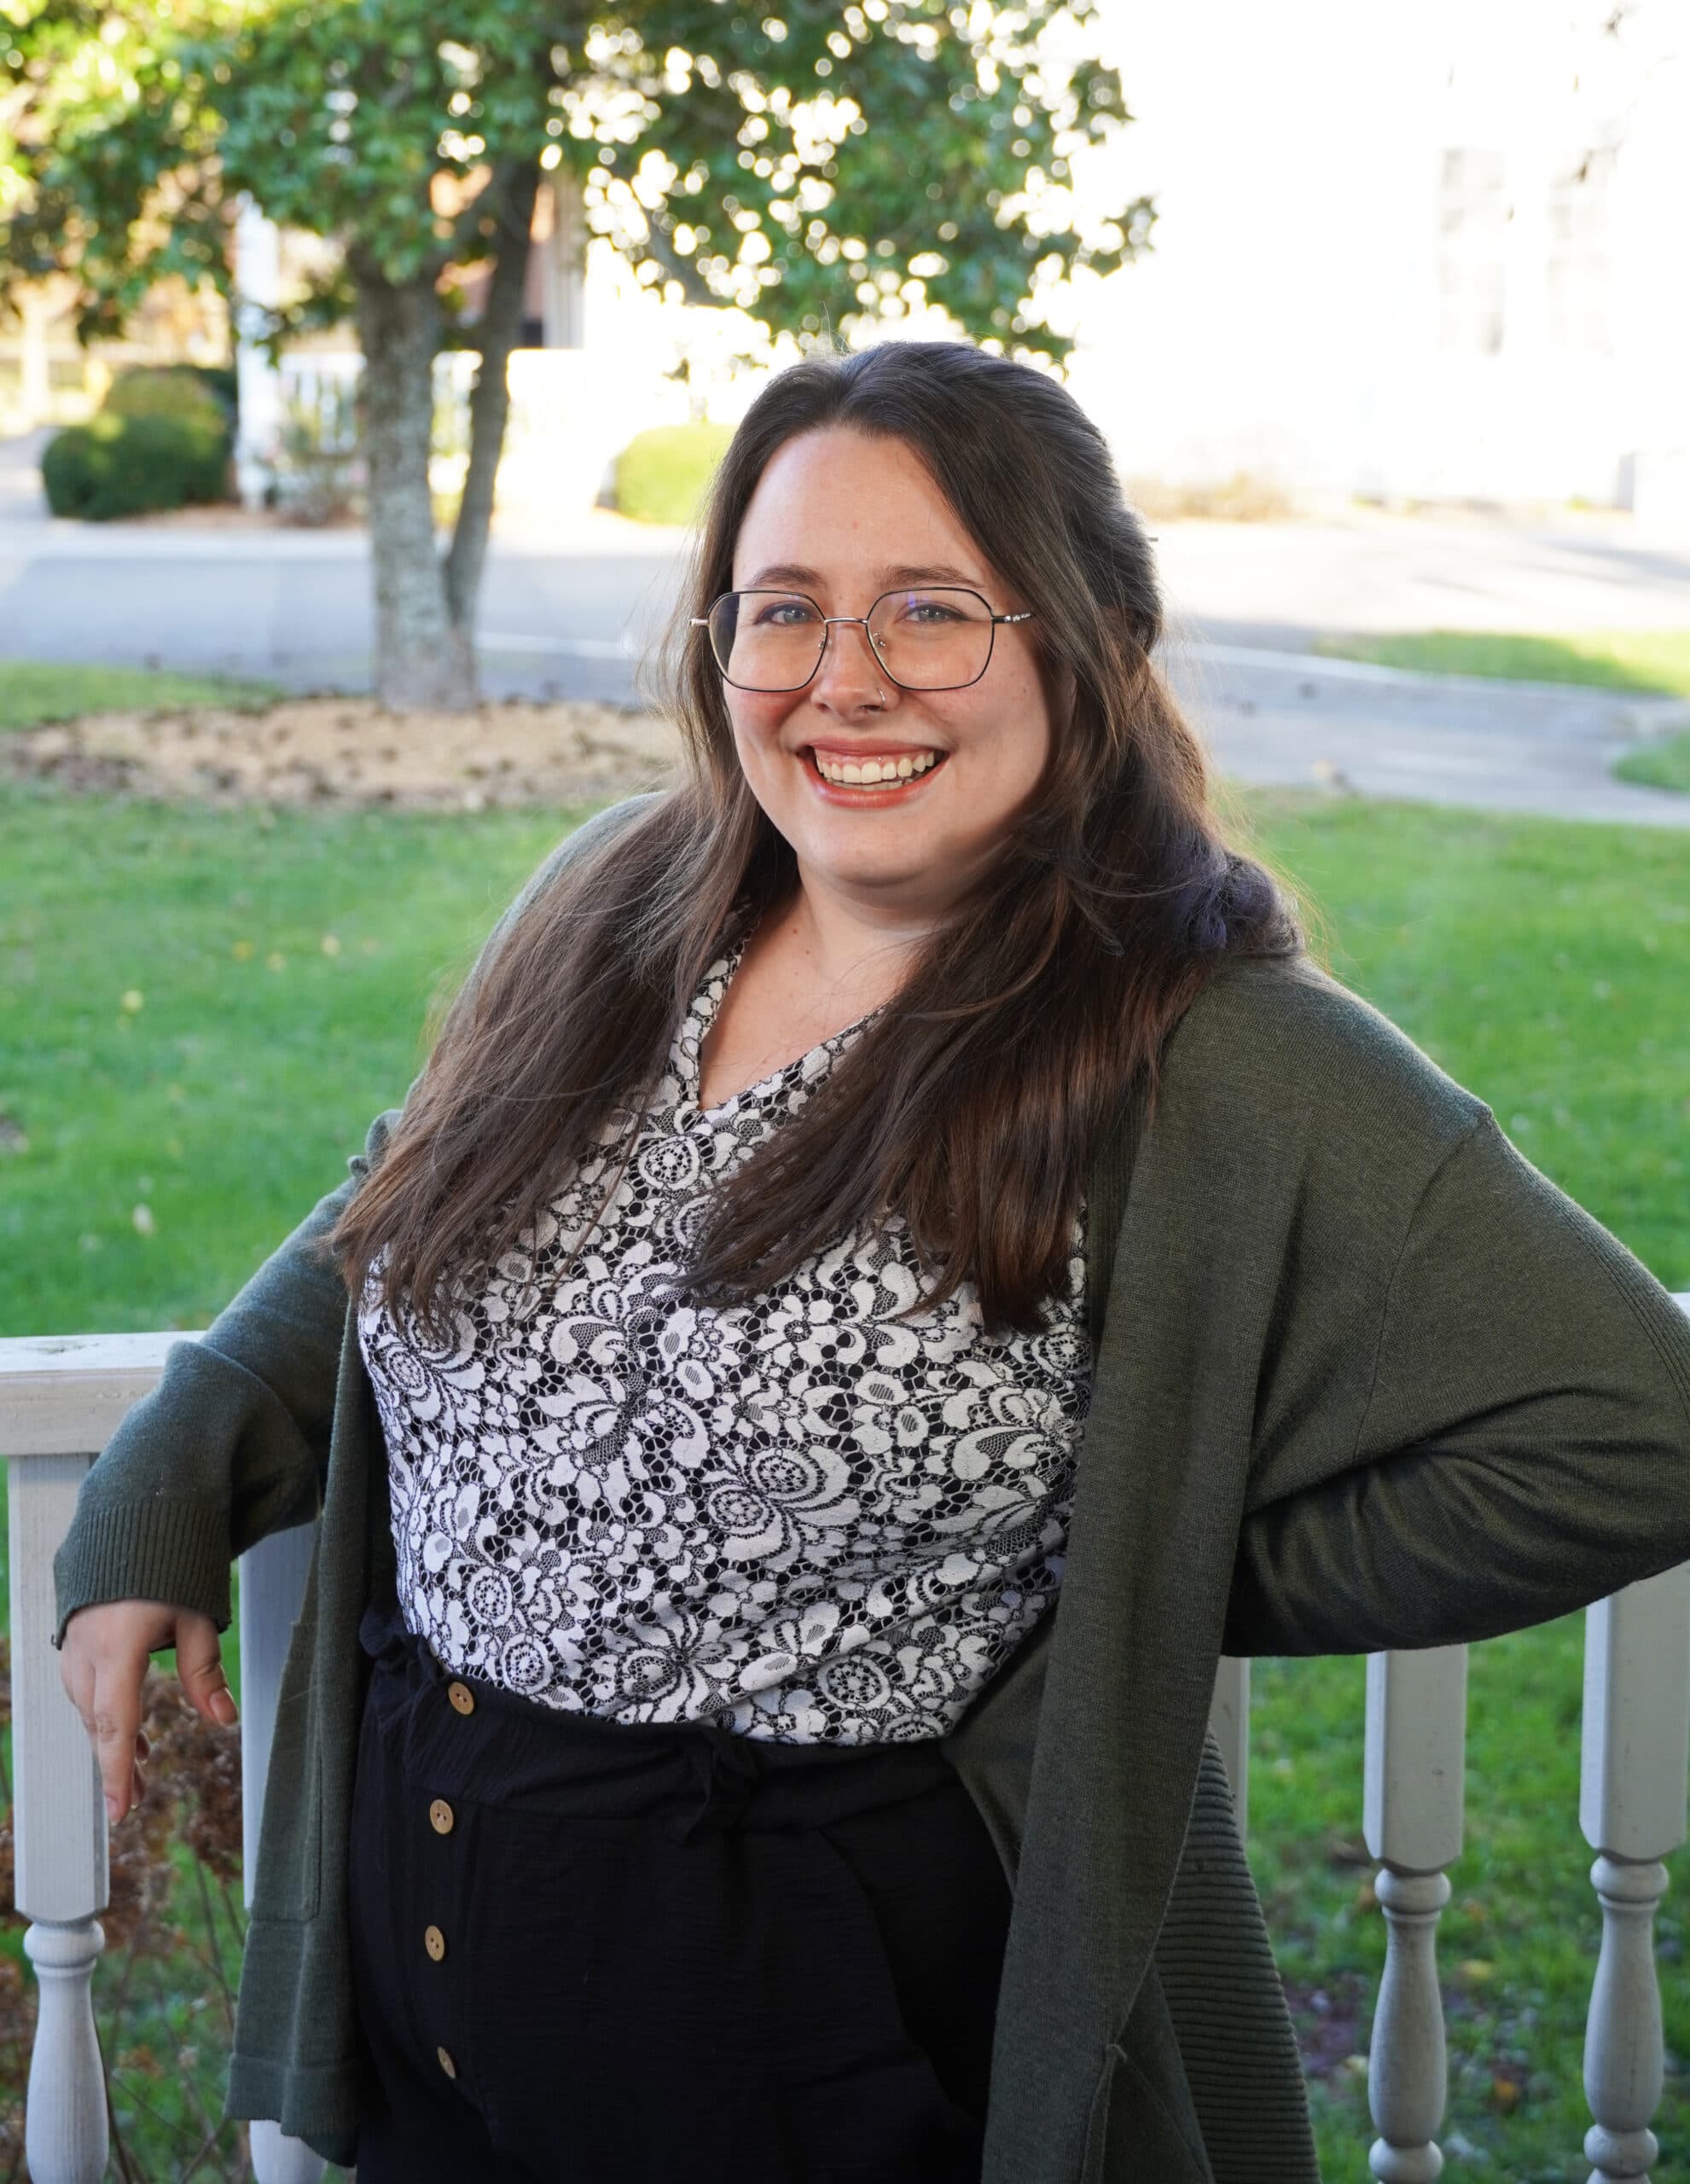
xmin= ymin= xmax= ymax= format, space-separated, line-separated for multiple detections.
xmin=332 ymin=343 xmax=1304 ymax=1341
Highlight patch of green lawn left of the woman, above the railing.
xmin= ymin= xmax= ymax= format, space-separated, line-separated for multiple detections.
xmin=0 ymin=788 xmax=607 ymax=1334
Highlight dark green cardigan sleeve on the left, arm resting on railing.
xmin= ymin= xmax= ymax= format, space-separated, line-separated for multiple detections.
xmin=52 ymin=795 xmax=651 ymax=1645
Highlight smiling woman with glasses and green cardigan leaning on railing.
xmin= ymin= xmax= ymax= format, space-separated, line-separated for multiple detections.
xmin=57 ymin=343 xmax=1690 ymax=2184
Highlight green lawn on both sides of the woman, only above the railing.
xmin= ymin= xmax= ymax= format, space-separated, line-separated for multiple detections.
xmin=0 ymin=787 xmax=1690 ymax=1334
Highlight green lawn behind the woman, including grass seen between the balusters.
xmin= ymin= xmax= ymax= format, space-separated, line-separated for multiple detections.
xmin=0 ymin=759 xmax=1690 ymax=2184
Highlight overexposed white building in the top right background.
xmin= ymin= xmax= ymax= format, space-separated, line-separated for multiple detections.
xmin=1072 ymin=0 xmax=1690 ymax=520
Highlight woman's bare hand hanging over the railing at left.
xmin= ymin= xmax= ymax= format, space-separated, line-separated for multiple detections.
xmin=59 ymin=1600 xmax=235 ymax=1821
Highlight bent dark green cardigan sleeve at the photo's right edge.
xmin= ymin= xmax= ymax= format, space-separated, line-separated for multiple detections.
xmin=1222 ymin=1109 xmax=1690 ymax=1655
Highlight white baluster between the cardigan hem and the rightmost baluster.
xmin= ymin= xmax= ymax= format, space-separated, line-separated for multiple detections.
xmin=1362 ymin=1645 xmax=1467 ymax=2184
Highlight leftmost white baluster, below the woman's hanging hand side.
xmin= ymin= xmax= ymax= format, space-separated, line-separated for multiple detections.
xmin=7 ymin=1455 xmax=109 ymax=2184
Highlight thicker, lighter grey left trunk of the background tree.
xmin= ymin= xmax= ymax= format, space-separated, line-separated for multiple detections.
xmin=354 ymin=266 xmax=476 ymax=712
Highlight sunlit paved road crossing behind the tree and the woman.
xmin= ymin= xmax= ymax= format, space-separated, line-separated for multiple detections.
xmin=0 ymin=434 xmax=1690 ymax=828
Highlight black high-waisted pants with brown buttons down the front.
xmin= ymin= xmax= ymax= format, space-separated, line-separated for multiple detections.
xmin=351 ymin=1603 xmax=1008 ymax=2184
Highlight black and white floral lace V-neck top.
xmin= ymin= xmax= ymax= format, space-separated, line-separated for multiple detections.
xmin=358 ymin=921 xmax=1092 ymax=1745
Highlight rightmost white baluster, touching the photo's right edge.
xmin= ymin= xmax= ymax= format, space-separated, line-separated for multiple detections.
xmin=1578 ymin=1564 xmax=1690 ymax=2184
